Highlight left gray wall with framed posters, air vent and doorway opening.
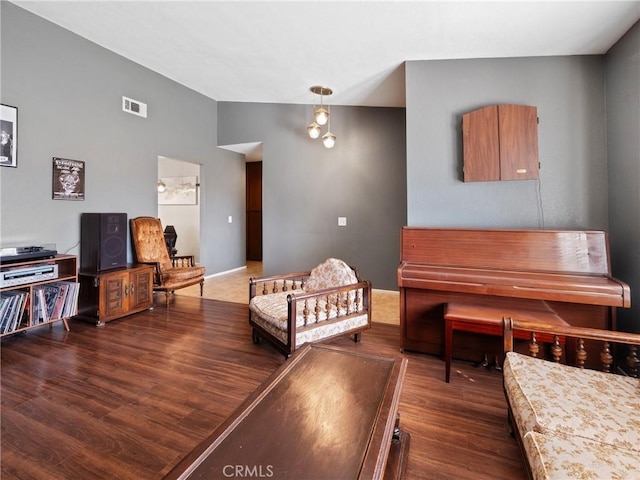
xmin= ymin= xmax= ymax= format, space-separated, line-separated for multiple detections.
xmin=0 ymin=2 xmax=245 ymax=273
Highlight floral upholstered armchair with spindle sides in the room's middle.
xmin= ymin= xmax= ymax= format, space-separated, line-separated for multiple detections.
xmin=249 ymin=258 xmax=371 ymax=357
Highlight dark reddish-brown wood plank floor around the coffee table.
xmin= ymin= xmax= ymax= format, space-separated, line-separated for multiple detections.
xmin=0 ymin=266 xmax=526 ymax=480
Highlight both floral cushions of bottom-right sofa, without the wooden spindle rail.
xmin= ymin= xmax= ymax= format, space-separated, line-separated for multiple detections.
xmin=503 ymin=352 xmax=640 ymax=479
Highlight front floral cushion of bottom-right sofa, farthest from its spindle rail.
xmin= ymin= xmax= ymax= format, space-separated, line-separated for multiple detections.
xmin=522 ymin=432 xmax=640 ymax=480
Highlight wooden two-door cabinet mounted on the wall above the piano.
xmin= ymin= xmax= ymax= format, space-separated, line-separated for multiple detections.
xmin=462 ymin=105 xmax=540 ymax=182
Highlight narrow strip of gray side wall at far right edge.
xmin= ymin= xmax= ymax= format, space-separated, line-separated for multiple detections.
xmin=605 ymin=23 xmax=640 ymax=332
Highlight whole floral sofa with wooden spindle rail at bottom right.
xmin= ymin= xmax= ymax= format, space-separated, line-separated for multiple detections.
xmin=503 ymin=318 xmax=640 ymax=480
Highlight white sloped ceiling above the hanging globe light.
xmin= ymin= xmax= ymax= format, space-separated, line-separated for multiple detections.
xmin=13 ymin=0 xmax=640 ymax=106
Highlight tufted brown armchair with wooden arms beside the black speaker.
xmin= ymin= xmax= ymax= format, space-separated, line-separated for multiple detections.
xmin=130 ymin=217 xmax=205 ymax=304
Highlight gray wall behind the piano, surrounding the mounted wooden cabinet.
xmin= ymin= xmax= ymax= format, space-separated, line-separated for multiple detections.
xmin=406 ymin=56 xmax=607 ymax=229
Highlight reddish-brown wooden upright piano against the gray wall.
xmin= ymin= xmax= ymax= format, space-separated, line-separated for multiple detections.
xmin=398 ymin=227 xmax=631 ymax=360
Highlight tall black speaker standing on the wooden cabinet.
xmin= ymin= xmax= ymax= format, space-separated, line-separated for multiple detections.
xmin=80 ymin=213 xmax=127 ymax=272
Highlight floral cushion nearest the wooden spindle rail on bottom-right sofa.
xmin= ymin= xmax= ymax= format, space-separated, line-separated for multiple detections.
xmin=504 ymin=352 xmax=640 ymax=452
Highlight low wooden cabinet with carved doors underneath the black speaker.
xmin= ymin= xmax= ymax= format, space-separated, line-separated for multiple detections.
xmin=78 ymin=265 xmax=153 ymax=326
